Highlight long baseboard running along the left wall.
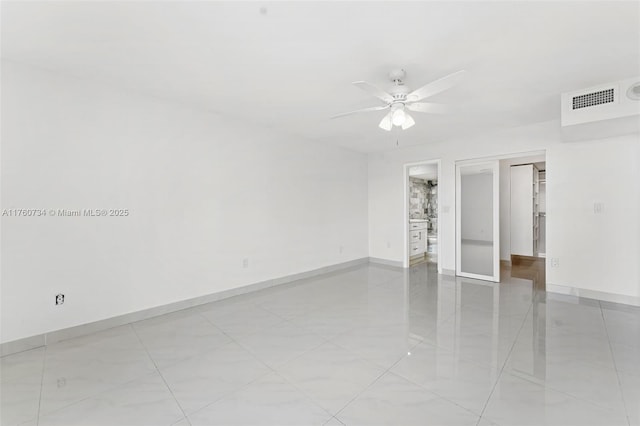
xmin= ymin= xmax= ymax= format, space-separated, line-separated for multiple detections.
xmin=0 ymin=257 xmax=369 ymax=356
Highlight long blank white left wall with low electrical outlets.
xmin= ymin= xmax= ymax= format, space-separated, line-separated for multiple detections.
xmin=1 ymin=62 xmax=368 ymax=342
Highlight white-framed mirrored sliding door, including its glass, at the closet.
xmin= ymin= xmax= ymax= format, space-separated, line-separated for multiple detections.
xmin=456 ymin=160 xmax=500 ymax=282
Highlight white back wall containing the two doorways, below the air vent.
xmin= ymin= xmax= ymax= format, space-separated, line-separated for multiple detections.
xmin=369 ymin=121 xmax=640 ymax=300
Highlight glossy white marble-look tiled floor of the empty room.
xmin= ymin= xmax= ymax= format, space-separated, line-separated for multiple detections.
xmin=0 ymin=263 xmax=640 ymax=426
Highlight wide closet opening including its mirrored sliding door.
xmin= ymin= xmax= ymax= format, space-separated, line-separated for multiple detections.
xmin=456 ymin=151 xmax=547 ymax=290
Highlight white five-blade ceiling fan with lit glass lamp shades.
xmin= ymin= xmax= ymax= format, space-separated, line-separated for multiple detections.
xmin=331 ymin=69 xmax=465 ymax=131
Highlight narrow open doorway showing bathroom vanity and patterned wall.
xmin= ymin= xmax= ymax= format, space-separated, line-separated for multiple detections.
xmin=403 ymin=160 xmax=442 ymax=274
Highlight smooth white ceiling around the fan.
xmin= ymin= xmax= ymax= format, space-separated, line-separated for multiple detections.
xmin=2 ymin=1 xmax=640 ymax=152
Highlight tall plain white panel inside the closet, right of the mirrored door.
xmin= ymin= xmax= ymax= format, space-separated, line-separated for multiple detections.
xmin=510 ymin=164 xmax=540 ymax=256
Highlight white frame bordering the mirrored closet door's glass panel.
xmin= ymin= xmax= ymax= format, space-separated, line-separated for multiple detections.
xmin=456 ymin=159 xmax=500 ymax=282
